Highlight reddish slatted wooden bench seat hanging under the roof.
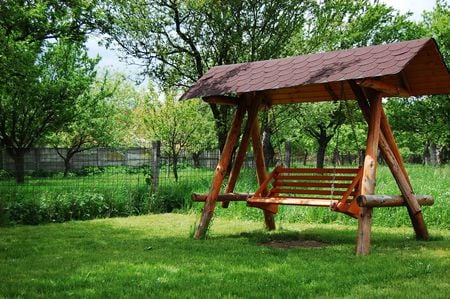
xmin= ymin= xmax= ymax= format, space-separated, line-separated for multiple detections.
xmin=247 ymin=166 xmax=362 ymax=218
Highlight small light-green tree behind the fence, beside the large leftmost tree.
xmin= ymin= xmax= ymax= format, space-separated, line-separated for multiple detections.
xmin=46 ymin=73 xmax=124 ymax=177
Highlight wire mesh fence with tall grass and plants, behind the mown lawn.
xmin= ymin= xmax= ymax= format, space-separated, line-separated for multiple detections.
xmin=0 ymin=142 xmax=366 ymax=224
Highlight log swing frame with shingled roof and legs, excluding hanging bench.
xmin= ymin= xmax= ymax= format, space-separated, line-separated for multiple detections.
xmin=181 ymin=39 xmax=450 ymax=255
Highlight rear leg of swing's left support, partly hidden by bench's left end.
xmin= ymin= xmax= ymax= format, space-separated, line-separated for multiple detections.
xmin=251 ymin=111 xmax=278 ymax=230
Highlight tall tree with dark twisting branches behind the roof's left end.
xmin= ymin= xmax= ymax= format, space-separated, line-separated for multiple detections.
xmin=101 ymin=0 xmax=312 ymax=149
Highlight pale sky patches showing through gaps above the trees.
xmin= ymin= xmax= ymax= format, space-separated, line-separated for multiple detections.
xmin=87 ymin=0 xmax=444 ymax=79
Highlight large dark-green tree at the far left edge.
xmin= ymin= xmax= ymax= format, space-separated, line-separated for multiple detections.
xmin=0 ymin=0 xmax=96 ymax=183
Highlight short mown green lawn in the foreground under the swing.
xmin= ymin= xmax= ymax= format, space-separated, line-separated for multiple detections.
xmin=0 ymin=214 xmax=450 ymax=298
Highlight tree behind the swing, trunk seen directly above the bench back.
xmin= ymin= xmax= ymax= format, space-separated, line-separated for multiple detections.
xmin=286 ymin=0 xmax=422 ymax=167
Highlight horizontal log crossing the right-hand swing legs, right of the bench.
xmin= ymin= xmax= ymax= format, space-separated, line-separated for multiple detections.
xmin=357 ymin=195 xmax=434 ymax=207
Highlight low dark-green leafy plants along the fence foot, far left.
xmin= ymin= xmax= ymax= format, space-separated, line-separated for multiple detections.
xmin=0 ymin=188 xmax=149 ymax=224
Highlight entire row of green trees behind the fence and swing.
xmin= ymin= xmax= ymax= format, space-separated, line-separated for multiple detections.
xmin=0 ymin=0 xmax=450 ymax=183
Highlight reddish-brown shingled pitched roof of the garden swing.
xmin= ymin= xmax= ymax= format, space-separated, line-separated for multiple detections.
xmin=181 ymin=38 xmax=450 ymax=105
